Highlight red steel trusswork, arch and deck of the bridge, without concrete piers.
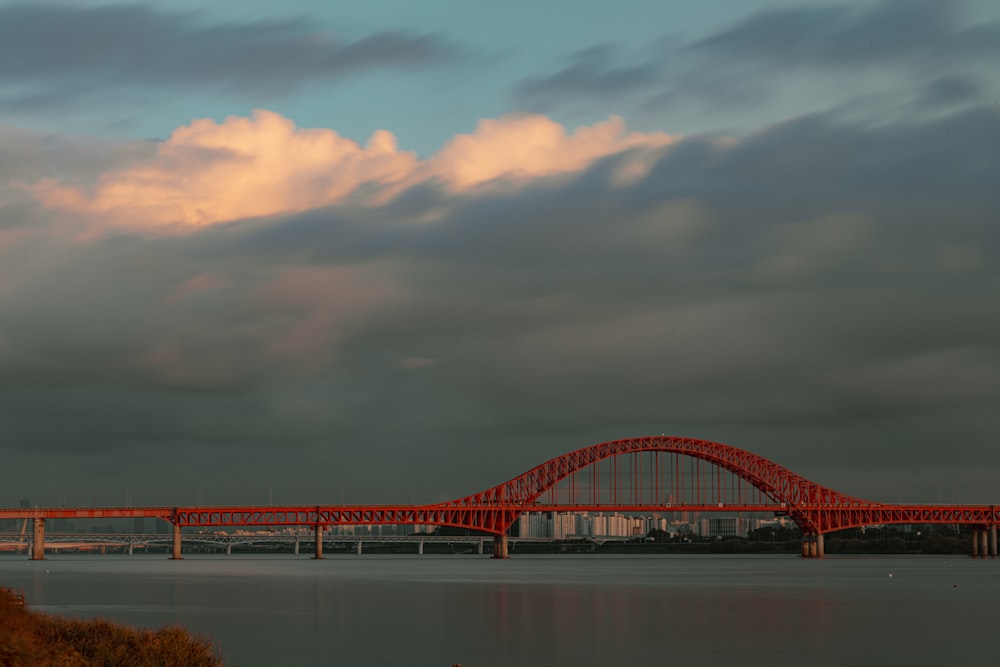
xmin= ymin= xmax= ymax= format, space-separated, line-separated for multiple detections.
xmin=0 ymin=436 xmax=1000 ymax=534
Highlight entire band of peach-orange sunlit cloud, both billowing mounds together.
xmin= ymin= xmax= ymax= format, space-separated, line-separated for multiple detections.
xmin=30 ymin=110 xmax=672 ymax=231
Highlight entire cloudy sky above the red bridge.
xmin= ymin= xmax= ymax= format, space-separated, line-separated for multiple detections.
xmin=0 ymin=0 xmax=1000 ymax=506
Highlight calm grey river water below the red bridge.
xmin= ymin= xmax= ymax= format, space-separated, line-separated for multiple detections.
xmin=0 ymin=555 xmax=1000 ymax=667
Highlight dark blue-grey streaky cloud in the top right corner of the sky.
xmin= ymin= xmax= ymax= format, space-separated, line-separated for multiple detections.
xmin=512 ymin=0 xmax=1000 ymax=128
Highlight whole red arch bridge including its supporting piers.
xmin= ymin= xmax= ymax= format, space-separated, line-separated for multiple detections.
xmin=0 ymin=436 xmax=1000 ymax=560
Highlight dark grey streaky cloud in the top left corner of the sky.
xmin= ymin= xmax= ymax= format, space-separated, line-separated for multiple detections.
xmin=0 ymin=4 xmax=456 ymax=107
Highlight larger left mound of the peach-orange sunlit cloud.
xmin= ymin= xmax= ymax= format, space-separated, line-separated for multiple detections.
xmin=33 ymin=111 xmax=417 ymax=228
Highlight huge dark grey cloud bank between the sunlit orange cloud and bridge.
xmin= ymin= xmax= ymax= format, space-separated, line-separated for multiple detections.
xmin=0 ymin=104 xmax=1000 ymax=502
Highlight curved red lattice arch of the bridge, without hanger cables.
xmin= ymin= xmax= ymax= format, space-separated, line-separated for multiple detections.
xmin=444 ymin=436 xmax=874 ymax=533
